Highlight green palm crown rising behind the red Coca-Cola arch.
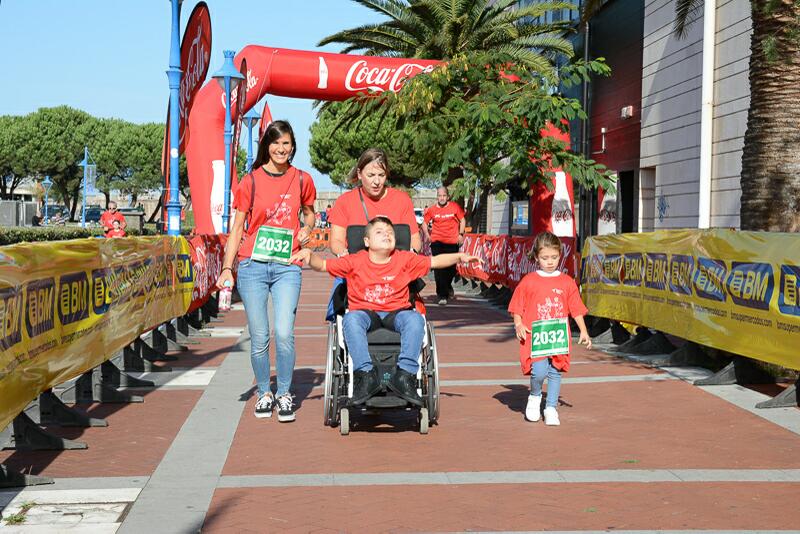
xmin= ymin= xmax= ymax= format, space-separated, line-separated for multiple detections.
xmin=319 ymin=0 xmax=575 ymax=77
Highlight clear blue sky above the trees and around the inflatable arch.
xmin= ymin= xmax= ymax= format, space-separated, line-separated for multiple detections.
xmin=0 ymin=0 xmax=381 ymax=190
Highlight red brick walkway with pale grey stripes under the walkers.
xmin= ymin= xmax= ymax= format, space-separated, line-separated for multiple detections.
xmin=0 ymin=271 xmax=800 ymax=533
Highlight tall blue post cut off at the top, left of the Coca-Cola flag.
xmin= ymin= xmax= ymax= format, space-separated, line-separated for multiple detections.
xmin=167 ymin=0 xmax=183 ymax=236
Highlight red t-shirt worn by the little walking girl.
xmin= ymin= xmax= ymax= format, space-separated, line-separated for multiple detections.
xmin=508 ymin=271 xmax=589 ymax=375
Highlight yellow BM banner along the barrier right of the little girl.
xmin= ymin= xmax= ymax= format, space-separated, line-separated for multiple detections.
xmin=581 ymin=230 xmax=800 ymax=369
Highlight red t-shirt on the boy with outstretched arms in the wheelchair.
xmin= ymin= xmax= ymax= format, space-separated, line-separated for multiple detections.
xmin=325 ymin=250 xmax=431 ymax=311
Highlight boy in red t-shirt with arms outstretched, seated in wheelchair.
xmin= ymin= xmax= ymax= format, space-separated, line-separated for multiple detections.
xmin=291 ymin=216 xmax=480 ymax=406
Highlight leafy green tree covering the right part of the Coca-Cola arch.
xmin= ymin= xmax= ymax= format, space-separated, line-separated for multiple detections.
xmin=345 ymin=49 xmax=611 ymax=226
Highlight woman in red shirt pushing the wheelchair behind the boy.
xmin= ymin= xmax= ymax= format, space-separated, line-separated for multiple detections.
xmin=328 ymin=148 xmax=422 ymax=256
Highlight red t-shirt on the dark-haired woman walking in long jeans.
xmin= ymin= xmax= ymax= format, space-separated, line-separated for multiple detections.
xmin=233 ymin=166 xmax=317 ymax=260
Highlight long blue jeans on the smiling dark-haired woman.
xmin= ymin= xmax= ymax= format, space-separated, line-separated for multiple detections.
xmin=236 ymin=258 xmax=302 ymax=396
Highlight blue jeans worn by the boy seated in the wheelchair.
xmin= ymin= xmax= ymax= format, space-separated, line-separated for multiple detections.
xmin=342 ymin=310 xmax=425 ymax=374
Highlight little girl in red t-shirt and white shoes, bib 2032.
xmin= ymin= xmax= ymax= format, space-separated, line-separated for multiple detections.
xmin=508 ymin=232 xmax=592 ymax=426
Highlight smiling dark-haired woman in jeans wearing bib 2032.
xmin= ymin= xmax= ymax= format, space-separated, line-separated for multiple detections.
xmin=217 ymin=121 xmax=317 ymax=422
